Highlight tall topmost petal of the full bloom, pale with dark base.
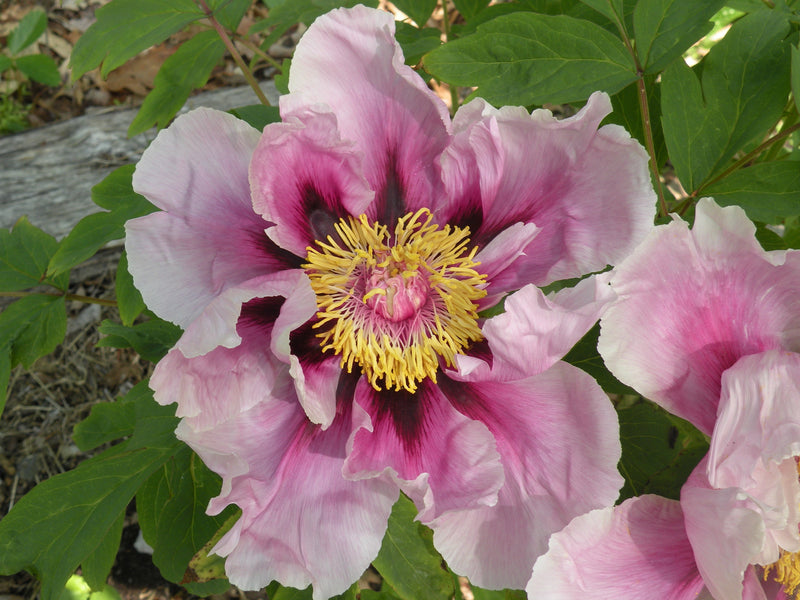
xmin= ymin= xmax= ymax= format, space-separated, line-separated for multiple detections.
xmin=281 ymin=6 xmax=450 ymax=223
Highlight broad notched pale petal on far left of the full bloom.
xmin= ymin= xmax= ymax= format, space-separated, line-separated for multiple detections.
xmin=125 ymin=109 xmax=297 ymax=327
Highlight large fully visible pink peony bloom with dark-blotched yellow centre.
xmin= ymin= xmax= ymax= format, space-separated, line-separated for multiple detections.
xmin=127 ymin=7 xmax=654 ymax=599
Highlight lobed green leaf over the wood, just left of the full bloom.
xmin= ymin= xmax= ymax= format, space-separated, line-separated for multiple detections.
xmin=47 ymin=165 xmax=157 ymax=276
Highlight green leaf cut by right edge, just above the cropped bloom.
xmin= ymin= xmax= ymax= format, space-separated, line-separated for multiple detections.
xmin=703 ymin=161 xmax=800 ymax=223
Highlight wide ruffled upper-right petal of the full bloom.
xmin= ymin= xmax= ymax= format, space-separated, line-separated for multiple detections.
xmin=441 ymin=93 xmax=655 ymax=291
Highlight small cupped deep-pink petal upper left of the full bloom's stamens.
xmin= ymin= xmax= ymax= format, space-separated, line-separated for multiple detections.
xmin=250 ymin=111 xmax=374 ymax=257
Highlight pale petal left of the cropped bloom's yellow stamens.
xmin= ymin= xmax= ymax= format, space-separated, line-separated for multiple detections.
xmin=681 ymin=457 xmax=764 ymax=600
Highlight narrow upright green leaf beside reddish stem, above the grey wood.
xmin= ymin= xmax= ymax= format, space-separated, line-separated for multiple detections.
xmin=128 ymin=30 xmax=225 ymax=137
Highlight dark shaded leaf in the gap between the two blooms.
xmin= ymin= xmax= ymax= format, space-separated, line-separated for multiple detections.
xmin=618 ymin=401 xmax=708 ymax=500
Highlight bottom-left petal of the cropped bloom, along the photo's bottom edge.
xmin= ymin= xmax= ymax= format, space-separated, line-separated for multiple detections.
xmin=527 ymin=495 xmax=711 ymax=600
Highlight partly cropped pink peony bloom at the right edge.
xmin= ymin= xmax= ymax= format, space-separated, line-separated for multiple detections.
xmin=528 ymin=199 xmax=800 ymax=600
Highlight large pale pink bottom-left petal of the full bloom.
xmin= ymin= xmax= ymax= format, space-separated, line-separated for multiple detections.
xmin=169 ymin=354 xmax=398 ymax=600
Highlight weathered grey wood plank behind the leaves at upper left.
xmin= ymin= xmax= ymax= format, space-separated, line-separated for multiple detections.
xmin=0 ymin=81 xmax=278 ymax=239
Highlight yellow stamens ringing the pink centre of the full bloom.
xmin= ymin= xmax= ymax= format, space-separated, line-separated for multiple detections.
xmin=303 ymin=208 xmax=486 ymax=393
